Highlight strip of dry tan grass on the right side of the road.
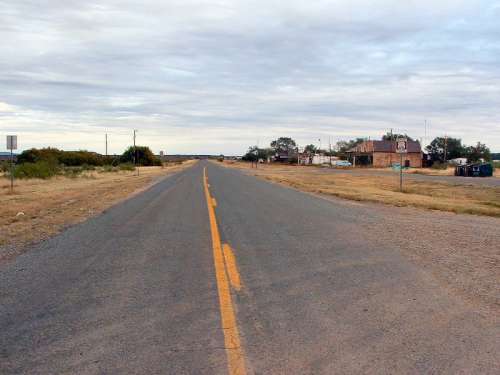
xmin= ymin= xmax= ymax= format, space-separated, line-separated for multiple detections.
xmin=224 ymin=162 xmax=500 ymax=217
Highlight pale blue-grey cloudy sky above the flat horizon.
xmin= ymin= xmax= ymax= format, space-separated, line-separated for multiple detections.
xmin=0 ymin=0 xmax=500 ymax=154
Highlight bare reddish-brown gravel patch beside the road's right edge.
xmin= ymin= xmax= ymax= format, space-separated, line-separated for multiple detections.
xmin=362 ymin=204 xmax=500 ymax=318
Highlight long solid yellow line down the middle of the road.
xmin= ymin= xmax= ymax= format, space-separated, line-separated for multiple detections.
xmin=203 ymin=168 xmax=246 ymax=375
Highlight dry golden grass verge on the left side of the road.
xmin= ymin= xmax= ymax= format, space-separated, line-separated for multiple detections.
xmin=0 ymin=161 xmax=195 ymax=262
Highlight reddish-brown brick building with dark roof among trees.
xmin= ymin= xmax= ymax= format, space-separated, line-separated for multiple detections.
xmin=347 ymin=141 xmax=423 ymax=168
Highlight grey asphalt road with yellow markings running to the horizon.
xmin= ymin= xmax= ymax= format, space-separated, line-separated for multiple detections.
xmin=0 ymin=162 xmax=500 ymax=374
